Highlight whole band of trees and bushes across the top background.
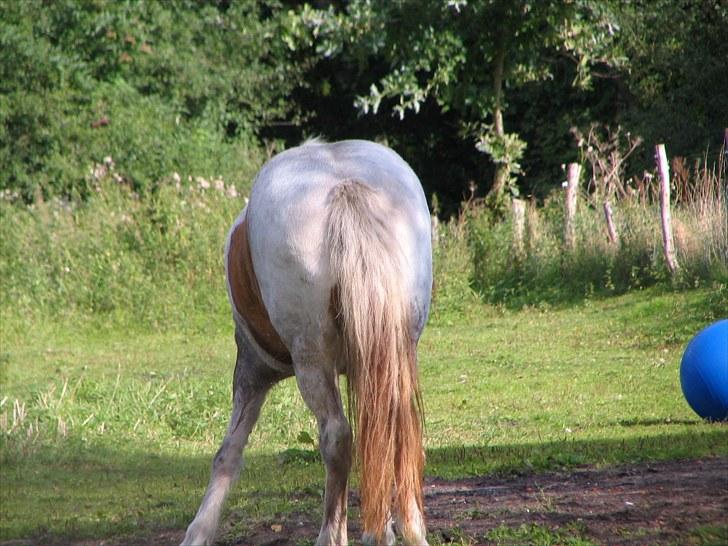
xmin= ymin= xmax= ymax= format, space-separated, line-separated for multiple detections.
xmin=0 ymin=0 xmax=728 ymax=210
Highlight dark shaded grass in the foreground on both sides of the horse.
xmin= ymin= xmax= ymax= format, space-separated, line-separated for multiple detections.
xmin=0 ymin=423 xmax=728 ymax=545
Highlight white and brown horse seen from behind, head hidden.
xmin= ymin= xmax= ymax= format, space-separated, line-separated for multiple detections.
xmin=182 ymin=139 xmax=432 ymax=546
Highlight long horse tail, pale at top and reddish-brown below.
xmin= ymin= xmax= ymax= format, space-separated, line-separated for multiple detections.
xmin=327 ymin=181 xmax=424 ymax=543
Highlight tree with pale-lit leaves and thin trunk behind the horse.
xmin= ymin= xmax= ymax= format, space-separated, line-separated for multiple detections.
xmin=289 ymin=0 xmax=622 ymax=203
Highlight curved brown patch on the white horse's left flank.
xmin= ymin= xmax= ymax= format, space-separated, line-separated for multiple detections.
xmin=227 ymin=218 xmax=293 ymax=364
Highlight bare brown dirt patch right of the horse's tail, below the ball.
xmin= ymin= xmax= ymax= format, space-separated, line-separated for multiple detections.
xmin=427 ymin=459 xmax=728 ymax=545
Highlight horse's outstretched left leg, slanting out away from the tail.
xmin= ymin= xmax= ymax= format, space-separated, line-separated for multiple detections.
xmin=182 ymin=332 xmax=283 ymax=546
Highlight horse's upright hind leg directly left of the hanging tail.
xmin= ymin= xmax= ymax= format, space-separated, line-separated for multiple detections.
xmin=294 ymin=346 xmax=352 ymax=546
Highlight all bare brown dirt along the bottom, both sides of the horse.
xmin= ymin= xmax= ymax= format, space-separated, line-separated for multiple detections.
xmin=14 ymin=458 xmax=728 ymax=546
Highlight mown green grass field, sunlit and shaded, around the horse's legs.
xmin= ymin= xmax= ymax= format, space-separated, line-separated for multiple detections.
xmin=0 ymin=282 xmax=728 ymax=542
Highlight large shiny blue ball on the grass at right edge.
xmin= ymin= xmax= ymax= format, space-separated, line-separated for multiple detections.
xmin=680 ymin=319 xmax=728 ymax=421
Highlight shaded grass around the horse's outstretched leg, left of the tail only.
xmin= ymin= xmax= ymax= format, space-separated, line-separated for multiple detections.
xmin=0 ymin=442 xmax=323 ymax=545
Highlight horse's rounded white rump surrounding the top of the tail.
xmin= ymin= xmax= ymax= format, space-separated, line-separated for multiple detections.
xmin=247 ymin=140 xmax=432 ymax=340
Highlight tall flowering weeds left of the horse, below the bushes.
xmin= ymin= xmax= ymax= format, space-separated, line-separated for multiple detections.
xmin=0 ymin=159 xmax=256 ymax=330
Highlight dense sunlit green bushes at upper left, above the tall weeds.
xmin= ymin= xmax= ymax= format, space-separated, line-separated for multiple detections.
xmin=0 ymin=0 xmax=305 ymax=202
